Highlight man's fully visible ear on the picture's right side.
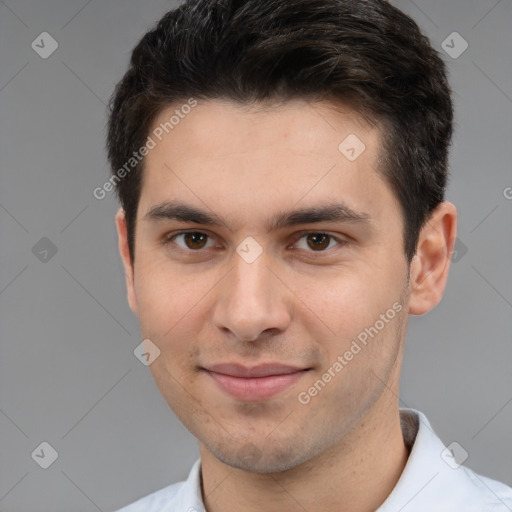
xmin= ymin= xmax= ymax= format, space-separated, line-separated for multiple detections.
xmin=409 ymin=202 xmax=457 ymax=315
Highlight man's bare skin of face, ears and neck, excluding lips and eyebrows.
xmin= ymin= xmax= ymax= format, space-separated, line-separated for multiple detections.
xmin=116 ymin=100 xmax=457 ymax=512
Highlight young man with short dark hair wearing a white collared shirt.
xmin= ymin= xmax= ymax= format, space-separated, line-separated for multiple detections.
xmin=107 ymin=0 xmax=512 ymax=512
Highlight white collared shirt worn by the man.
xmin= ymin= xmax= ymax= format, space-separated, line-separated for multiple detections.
xmin=117 ymin=408 xmax=512 ymax=512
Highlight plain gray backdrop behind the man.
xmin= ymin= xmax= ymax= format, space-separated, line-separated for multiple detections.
xmin=0 ymin=0 xmax=512 ymax=512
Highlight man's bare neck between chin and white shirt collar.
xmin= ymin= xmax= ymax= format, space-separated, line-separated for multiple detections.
xmin=200 ymin=396 xmax=409 ymax=512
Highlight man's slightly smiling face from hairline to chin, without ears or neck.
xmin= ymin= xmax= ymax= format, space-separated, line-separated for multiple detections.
xmin=121 ymin=101 xmax=408 ymax=472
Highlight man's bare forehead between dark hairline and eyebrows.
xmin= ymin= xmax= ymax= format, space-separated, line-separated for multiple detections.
xmin=140 ymin=100 xmax=394 ymax=228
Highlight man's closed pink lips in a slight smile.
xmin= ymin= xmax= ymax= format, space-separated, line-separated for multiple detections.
xmin=205 ymin=364 xmax=309 ymax=402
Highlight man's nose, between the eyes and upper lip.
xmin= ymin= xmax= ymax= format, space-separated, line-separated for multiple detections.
xmin=213 ymin=246 xmax=293 ymax=341
